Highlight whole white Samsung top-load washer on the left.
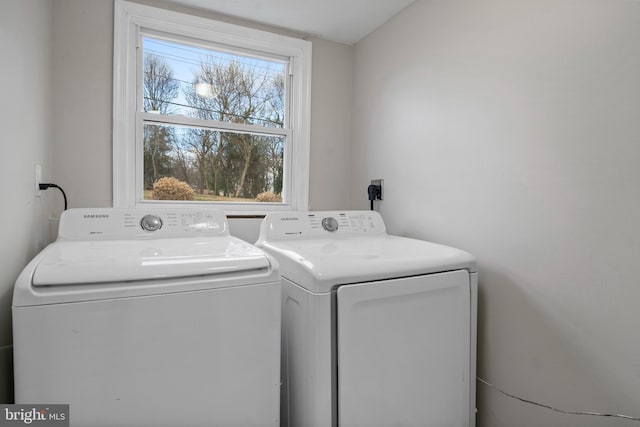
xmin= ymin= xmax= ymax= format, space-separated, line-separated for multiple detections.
xmin=12 ymin=209 xmax=280 ymax=427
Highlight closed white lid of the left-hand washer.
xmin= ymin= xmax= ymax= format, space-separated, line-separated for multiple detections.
xmin=32 ymin=236 xmax=270 ymax=286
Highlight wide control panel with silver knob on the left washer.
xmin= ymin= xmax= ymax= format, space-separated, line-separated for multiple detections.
xmin=58 ymin=208 xmax=229 ymax=240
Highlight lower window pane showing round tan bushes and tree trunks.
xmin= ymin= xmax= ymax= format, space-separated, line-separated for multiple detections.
xmin=143 ymin=123 xmax=286 ymax=203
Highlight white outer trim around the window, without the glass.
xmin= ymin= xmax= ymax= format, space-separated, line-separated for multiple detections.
xmin=113 ymin=0 xmax=311 ymax=215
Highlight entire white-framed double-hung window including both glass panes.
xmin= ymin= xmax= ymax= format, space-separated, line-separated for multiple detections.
xmin=113 ymin=0 xmax=311 ymax=214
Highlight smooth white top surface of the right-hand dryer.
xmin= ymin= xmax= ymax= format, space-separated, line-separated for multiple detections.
xmin=260 ymin=234 xmax=476 ymax=293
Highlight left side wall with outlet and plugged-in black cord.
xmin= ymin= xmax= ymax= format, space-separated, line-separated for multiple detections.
xmin=0 ymin=0 xmax=53 ymax=402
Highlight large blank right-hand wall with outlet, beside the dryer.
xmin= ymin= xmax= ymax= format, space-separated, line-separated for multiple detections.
xmin=351 ymin=0 xmax=640 ymax=427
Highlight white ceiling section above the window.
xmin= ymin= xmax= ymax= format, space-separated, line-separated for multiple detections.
xmin=172 ymin=0 xmax=415 ymax=44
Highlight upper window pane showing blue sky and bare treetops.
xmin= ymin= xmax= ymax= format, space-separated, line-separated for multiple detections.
xmin=143 ymin=37 xmax=286 ymax=128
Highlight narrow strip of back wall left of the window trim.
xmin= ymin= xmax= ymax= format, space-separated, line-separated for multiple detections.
xmin=53 ymin=0 xmax=113 ymax=208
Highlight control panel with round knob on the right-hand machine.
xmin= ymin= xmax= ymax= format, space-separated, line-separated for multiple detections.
xmin=259 ymin=211 xmax=386 ymax=240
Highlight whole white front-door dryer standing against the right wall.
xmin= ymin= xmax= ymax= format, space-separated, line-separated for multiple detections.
xmin=256 ymin=211 xmax=477 ymax=427
